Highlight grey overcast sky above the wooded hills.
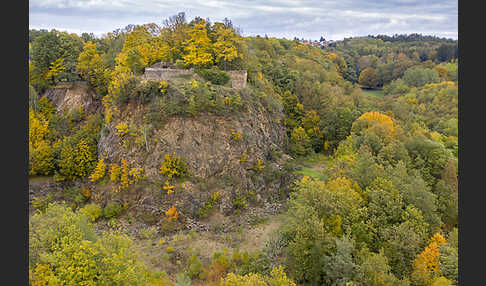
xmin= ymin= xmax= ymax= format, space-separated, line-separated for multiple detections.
xmin=29 ymin=0 xmax=458 ymax=40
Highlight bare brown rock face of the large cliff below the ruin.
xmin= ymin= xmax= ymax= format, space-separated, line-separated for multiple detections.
xmin=98 ymin=95 xmax=287 ymax=217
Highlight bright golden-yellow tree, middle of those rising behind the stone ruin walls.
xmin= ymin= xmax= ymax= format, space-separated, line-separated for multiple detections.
xmin=182 ymin=20 xmax=213 ymax=67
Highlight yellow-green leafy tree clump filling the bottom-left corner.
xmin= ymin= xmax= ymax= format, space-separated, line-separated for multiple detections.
xmin=29 ymin=204 xmax=158 ymax=285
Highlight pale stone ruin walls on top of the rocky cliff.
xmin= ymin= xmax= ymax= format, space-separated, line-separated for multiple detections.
xmin=142 ymin=62 xmax=248 ymax=88
